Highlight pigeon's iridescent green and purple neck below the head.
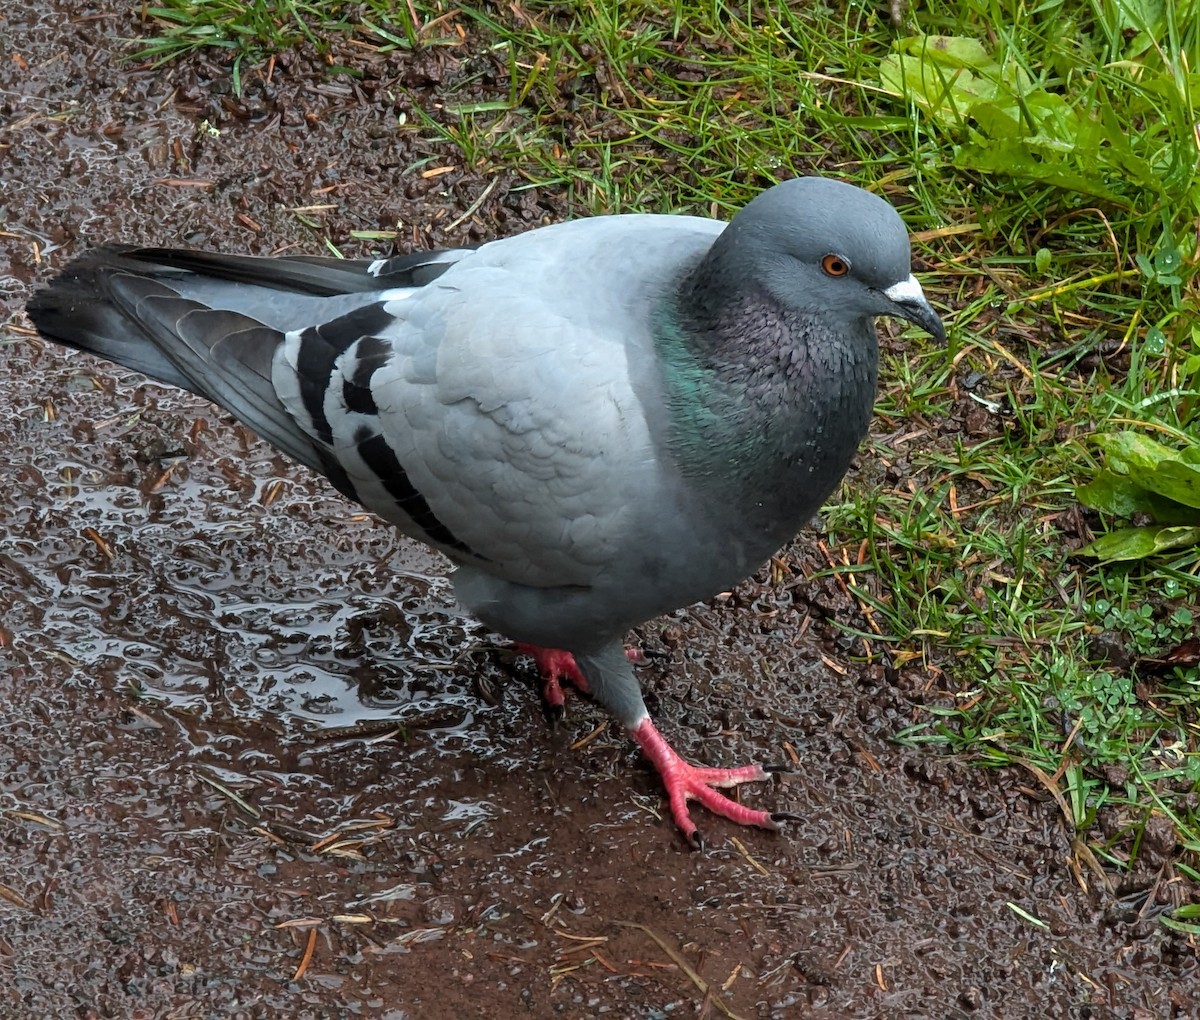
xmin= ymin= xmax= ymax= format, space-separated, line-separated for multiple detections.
xmin=656 ymin=271 xmax=878 ymax=532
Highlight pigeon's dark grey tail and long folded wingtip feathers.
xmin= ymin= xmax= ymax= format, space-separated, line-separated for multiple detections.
xmin=26 ymin=245 xmax=469 ymax=499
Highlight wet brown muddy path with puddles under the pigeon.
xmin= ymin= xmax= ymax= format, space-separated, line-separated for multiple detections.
xmin=0 ymin=0 xmax=1200 ymax=1020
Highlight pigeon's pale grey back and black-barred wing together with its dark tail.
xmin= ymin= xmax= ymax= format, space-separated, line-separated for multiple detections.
xmin=30 ymin=216 xmax=724 ymax=587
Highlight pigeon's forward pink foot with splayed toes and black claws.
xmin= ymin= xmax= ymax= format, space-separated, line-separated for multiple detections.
xmin=630 ymin=719 xmax=790 ymax=850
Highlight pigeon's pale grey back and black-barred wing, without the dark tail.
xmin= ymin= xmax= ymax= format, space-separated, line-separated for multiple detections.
xmin=274 ymin=217 xmax=720 ymax=587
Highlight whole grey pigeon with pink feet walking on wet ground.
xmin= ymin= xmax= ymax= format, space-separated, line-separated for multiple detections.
xmin=28 ymin=176 xmax=946 ymax=847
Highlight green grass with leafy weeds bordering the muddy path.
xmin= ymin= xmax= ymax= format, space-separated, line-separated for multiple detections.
xmin=131 ymin=0 xmax=1200 ymax=883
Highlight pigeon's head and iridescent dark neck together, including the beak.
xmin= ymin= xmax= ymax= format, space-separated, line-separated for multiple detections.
xmin=658 ymin=178 xmax=946 ymax=525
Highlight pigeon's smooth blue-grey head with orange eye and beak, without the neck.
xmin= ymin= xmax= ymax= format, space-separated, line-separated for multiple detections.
xmin=714 ymin=178 xmax=946 ymax=341
